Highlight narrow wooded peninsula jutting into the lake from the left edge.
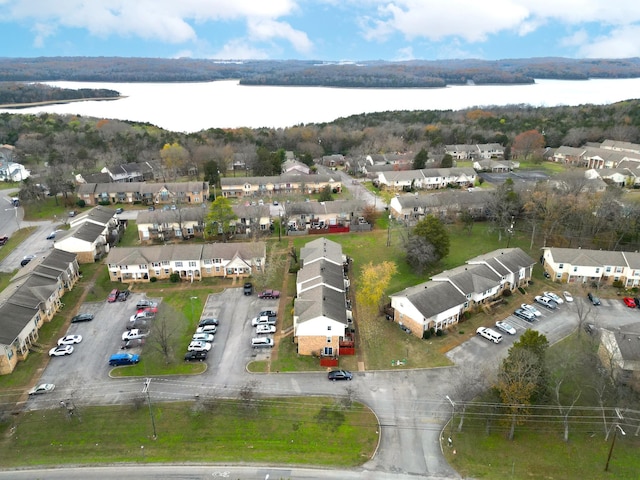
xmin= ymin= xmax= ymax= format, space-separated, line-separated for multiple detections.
xmin=0 ymin=82 xmax=120 ymax=108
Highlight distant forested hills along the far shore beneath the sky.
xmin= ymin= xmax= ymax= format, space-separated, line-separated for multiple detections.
xmin=0 ymin=57 xmax=640 ymax=88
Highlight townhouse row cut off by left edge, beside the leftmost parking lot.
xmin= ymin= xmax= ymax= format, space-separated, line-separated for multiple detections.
xmin=0 ymin=249 xmax=80 ymax=375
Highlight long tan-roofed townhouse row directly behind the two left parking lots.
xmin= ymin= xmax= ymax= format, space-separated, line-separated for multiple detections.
xmin=106 ymin=242 xmax=266 ymax=283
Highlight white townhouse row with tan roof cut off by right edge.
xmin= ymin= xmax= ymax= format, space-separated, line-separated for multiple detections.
xmin=541 ymin=247 xmax=640 ymax=288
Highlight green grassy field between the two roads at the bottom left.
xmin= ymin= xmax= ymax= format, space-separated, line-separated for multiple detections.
xmin=0 ymin=397 xmax=378 ymax=468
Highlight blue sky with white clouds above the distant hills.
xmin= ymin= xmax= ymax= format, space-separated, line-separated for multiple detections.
xmin=0 ymin=0 xmax=640 ymax=62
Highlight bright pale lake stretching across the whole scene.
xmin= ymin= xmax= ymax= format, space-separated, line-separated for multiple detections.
xmin=0 ymin=78 xmax=640 ymax=132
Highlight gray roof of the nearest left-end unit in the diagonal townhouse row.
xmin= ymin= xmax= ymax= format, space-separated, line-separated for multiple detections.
xmin=392 ymin=281 xmax=467 ymax=318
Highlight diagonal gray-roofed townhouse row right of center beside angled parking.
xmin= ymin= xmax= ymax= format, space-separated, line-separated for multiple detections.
xmin=390 ymin=248 xmax=535 ymax=338
